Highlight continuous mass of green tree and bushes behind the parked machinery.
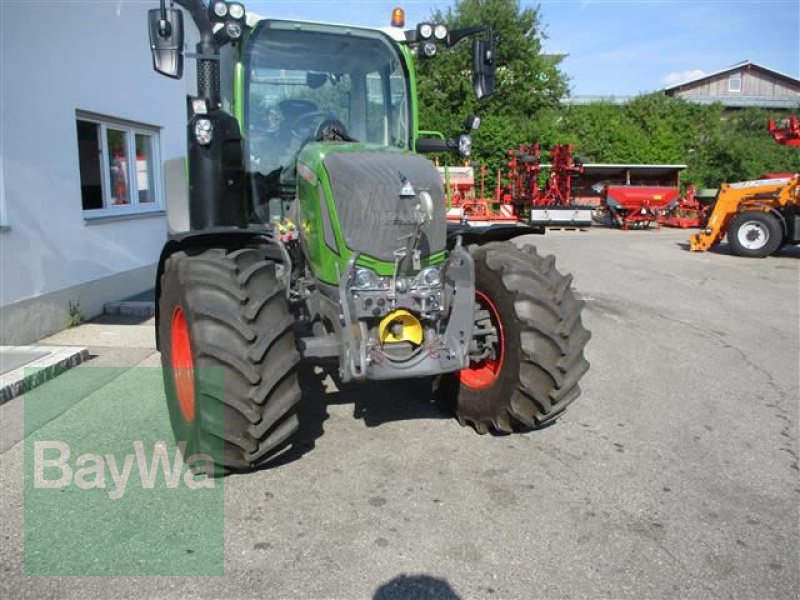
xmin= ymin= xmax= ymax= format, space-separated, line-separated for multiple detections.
xmin=417 ymin=0 xmax=800 ymax=188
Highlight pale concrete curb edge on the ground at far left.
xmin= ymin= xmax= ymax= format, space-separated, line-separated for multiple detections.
xmin=0 ymin=346 xmax=89 ymax=405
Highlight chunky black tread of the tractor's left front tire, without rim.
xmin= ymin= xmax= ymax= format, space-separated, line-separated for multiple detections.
xmin=160 ymin=245 xmax=301 ymax=472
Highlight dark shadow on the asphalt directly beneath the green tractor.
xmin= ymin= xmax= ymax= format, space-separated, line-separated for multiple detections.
xmin=264 ymin=363 xmax=451 ymax=469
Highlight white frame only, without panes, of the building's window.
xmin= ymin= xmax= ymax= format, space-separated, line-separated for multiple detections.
xmin=75 ymin=111 xmax=164 ymax=220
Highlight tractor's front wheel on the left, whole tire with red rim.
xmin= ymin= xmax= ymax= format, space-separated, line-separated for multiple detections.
xmin=158 ymin=246 xmax=300 ymax=473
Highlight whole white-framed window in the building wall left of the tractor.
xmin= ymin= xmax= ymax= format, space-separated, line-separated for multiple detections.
xmin=77 ymin=114 xmax=162 ymax=217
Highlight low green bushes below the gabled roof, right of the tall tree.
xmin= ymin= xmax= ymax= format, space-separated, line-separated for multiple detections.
xmin=548 ymin=93 xmax=800 ymax=188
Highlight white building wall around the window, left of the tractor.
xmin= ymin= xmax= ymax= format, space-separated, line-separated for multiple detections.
xmin=0 ymin=0 xmax=186 ymax=343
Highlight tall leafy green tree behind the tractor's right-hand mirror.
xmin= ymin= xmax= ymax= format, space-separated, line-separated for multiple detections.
xmin=417 ymin=0 xmax=567 ymax=167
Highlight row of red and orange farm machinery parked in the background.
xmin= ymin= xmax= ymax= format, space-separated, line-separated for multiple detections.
xmin=445 ymin=116 xmax=800 ymax=255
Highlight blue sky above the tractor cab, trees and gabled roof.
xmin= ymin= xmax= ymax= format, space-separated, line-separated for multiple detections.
xmin=247 ymin=0 xmax=800 ymax=96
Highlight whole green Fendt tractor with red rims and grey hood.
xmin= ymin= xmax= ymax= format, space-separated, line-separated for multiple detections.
xmin=148 ymin=0 xmax=590 ymax=472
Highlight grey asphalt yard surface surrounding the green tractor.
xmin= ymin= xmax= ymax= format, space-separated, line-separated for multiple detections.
xmin=0 ymin=229 xmax=800 ymax=599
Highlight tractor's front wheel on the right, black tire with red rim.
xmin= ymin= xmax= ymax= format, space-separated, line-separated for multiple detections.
xmin=440 ymin=242 xmax=591 ymax=434
